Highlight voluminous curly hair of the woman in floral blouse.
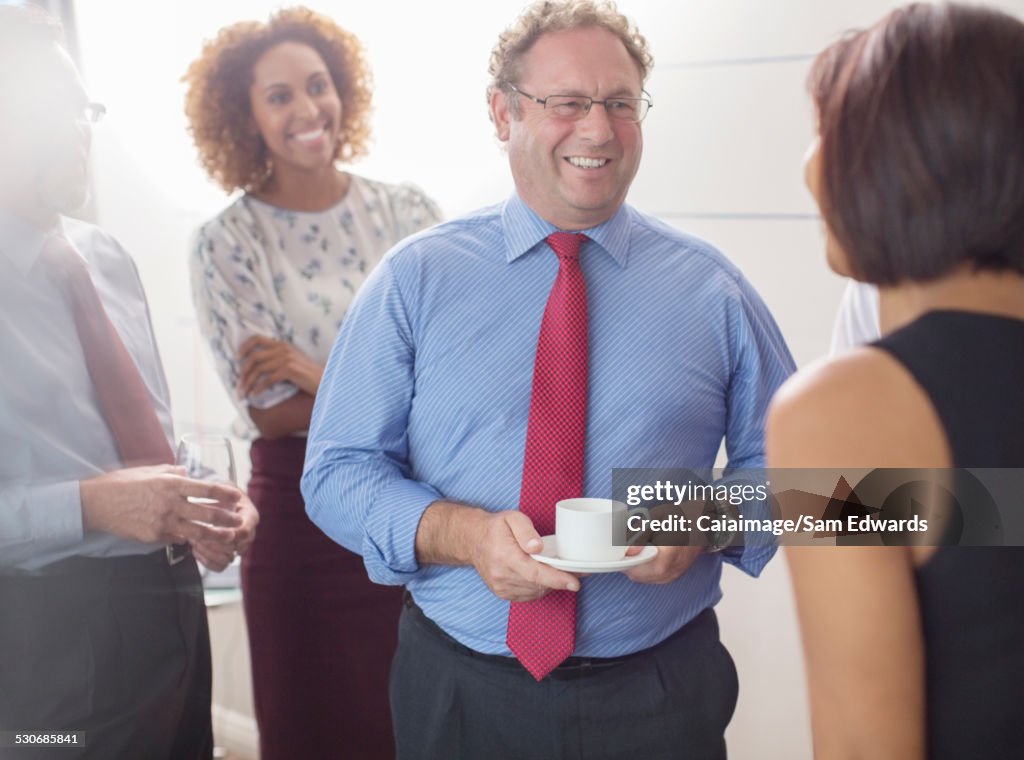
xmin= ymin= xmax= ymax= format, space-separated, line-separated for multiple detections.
xmin=181 ymin=7 xmax=373 ymax=193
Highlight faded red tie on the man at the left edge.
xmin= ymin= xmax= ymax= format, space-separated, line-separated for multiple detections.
xmin=42 ymin=235 xmax=174 ymax=467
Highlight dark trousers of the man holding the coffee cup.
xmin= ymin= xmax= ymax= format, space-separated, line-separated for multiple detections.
xmin=391 ymin=598 xmax=737 ymax=760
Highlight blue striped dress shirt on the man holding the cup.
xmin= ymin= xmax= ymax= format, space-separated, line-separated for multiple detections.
xmin=302 ymin=196 xmax=794 ymax=657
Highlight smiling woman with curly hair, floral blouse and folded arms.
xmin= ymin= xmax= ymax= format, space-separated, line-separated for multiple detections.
xmin=184 ymin=8 xmax=439 ymax=760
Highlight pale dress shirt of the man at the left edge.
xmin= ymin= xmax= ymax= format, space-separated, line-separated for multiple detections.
xmin=0 ymin=211 xmax=173 ymax=573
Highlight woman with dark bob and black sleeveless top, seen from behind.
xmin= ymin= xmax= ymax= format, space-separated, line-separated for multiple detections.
xmin=767 ymin=4 xmax=1024 ymax=760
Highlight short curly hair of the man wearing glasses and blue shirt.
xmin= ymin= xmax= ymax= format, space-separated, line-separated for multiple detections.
xmin=487 ymin=0 xmax=654 ymax=118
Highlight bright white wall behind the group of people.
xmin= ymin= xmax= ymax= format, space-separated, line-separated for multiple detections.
xmin=72 ymin=0 xmax=1024 ymax=760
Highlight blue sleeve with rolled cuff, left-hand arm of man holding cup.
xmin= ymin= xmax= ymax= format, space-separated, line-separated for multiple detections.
xmin=302 ymin=259 xmax=441 ymax=585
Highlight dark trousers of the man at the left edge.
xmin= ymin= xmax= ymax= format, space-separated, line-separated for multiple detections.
xmin=0 ymin=551 xmax=213 ymax=760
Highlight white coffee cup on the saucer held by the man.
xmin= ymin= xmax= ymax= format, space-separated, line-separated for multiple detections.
xmin=555 ymin=497 xmax=647 ymax=562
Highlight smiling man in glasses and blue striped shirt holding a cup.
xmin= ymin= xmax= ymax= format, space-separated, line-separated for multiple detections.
xmin=302 ymin=1 xmax=793 ymax=758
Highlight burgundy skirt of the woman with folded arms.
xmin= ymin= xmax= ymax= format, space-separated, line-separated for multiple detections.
xmin=242 ymin=436 xmax=401 ymax=760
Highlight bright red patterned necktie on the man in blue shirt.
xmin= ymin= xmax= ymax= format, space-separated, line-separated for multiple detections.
xmin=506 ymin=233 xmax=587 ymax=681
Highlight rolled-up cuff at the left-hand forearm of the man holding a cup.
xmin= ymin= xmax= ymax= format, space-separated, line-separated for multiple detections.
xmin=362 ymin=479 xmax=441 ymax=585
